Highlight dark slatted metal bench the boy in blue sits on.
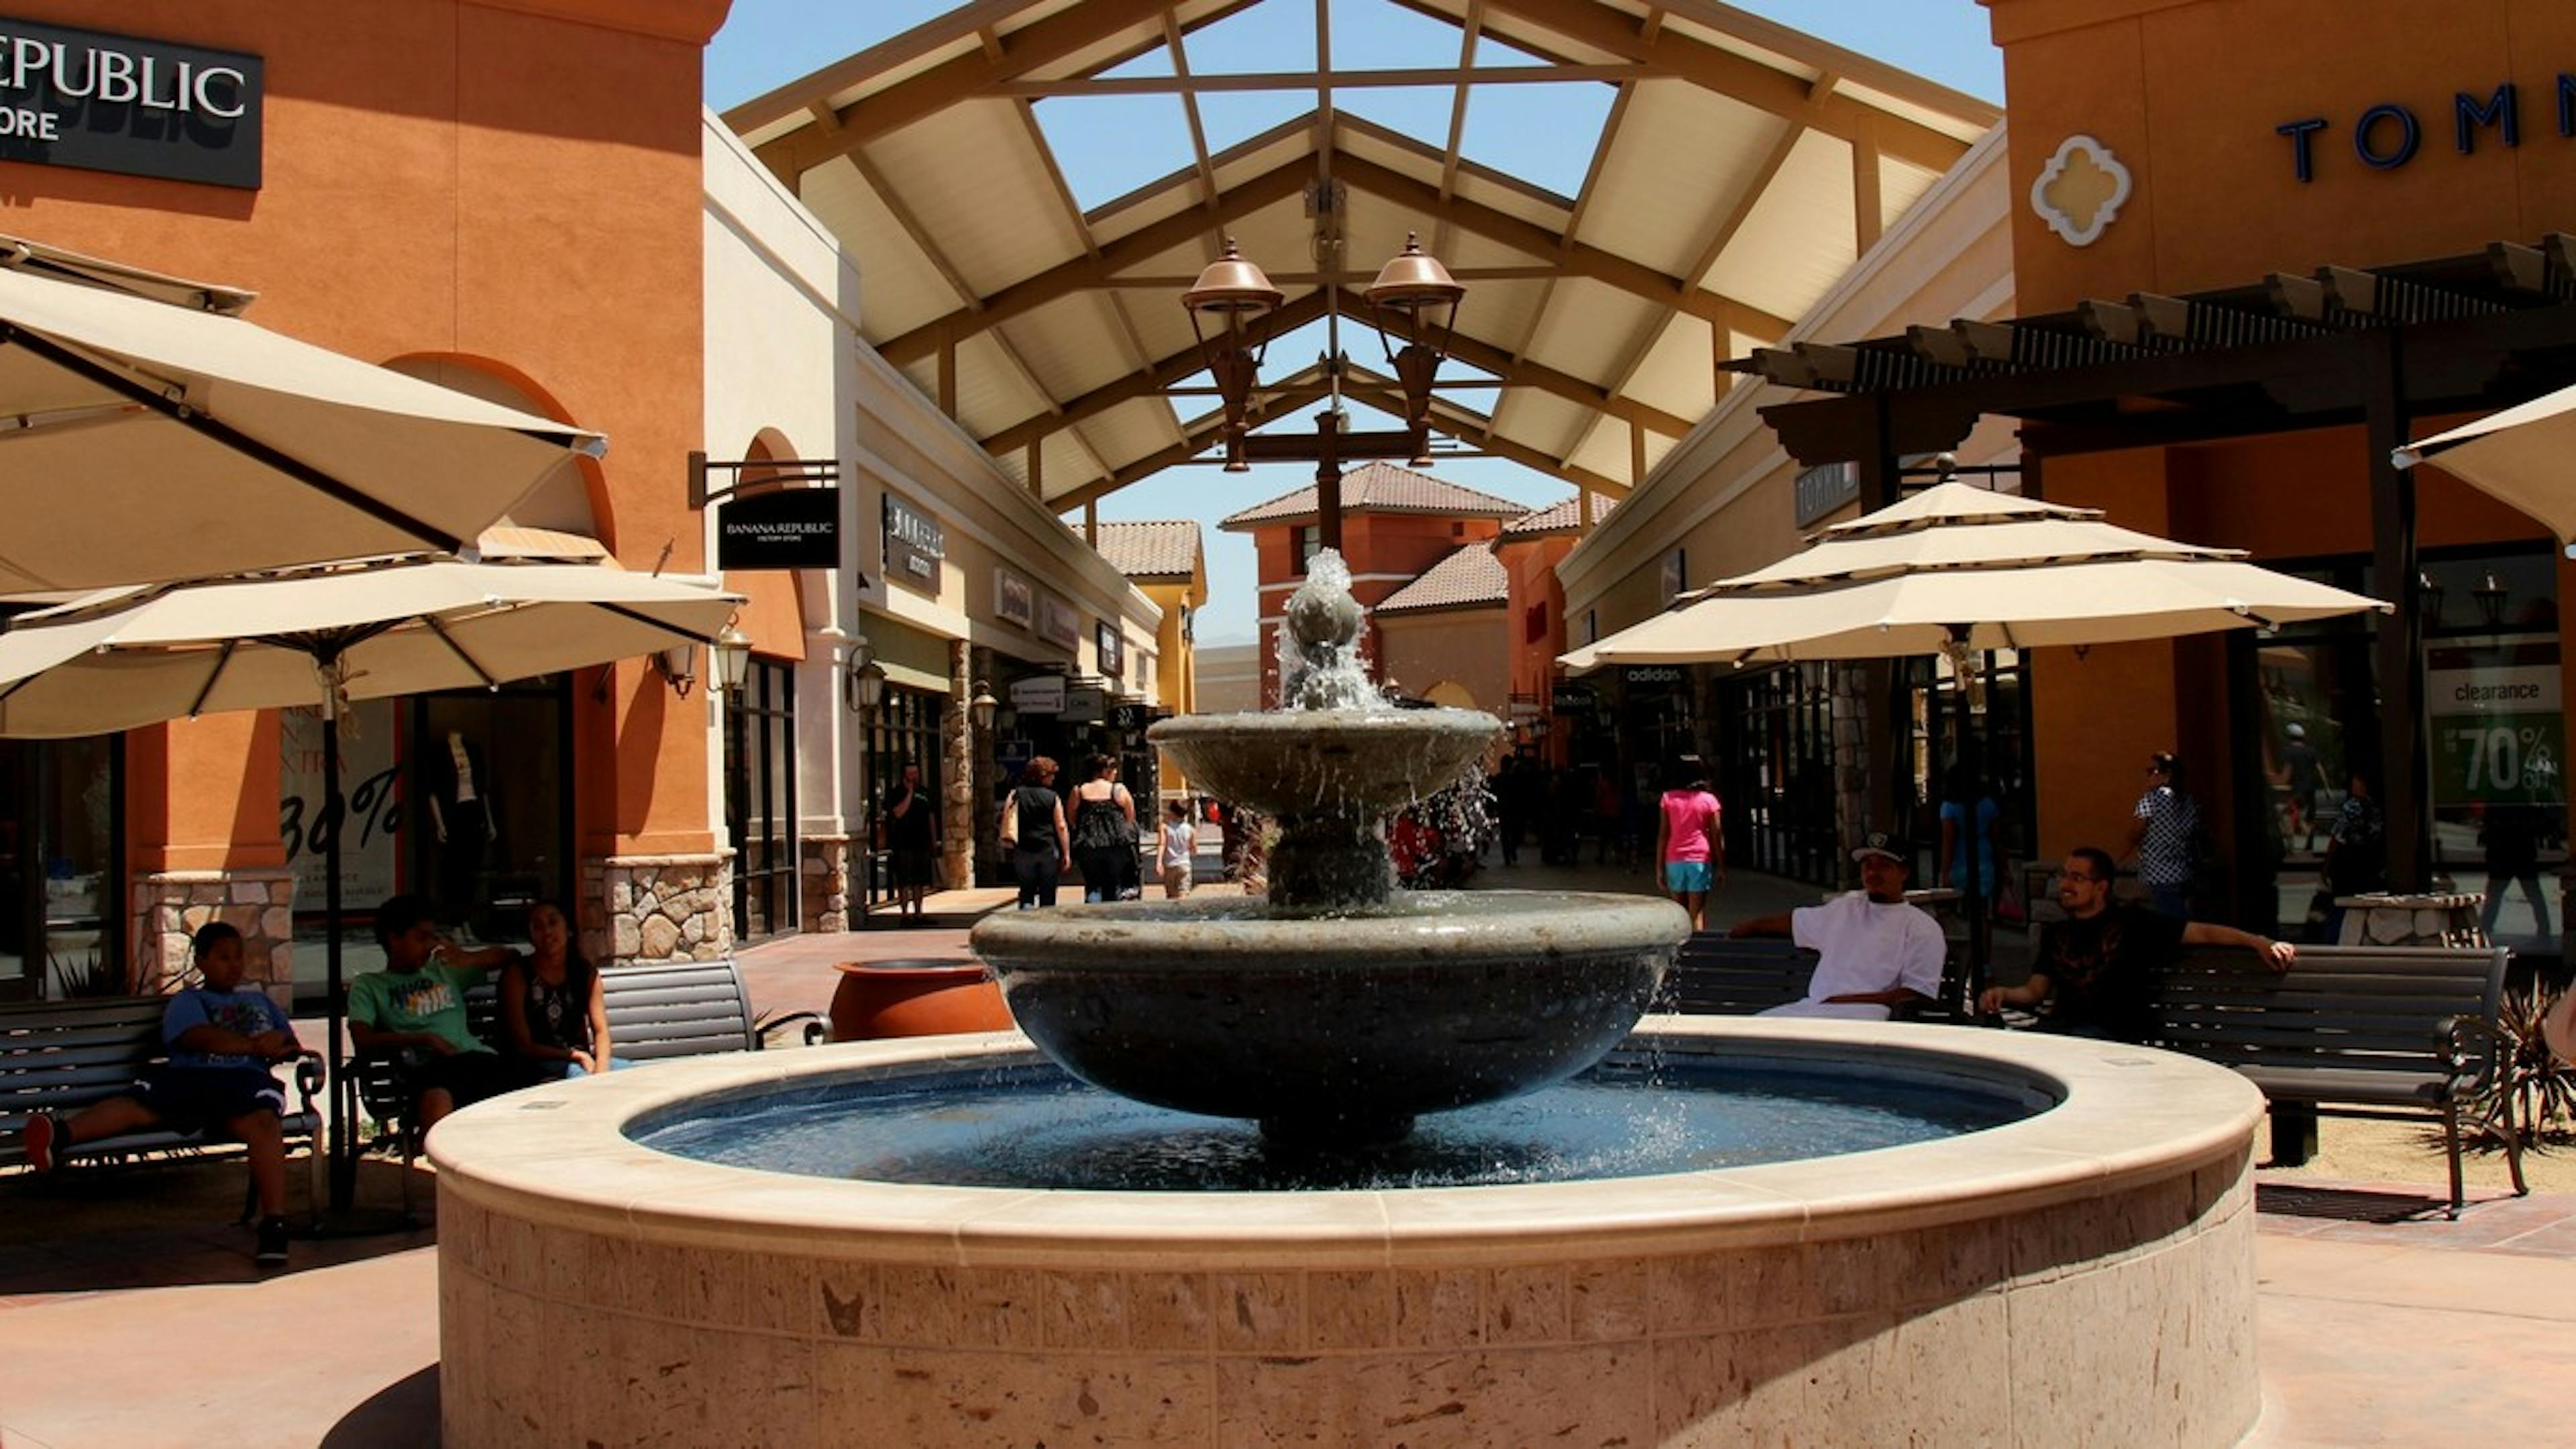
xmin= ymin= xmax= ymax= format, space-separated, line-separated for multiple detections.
xmin=0 ymin=996 xmax=322 ymax=1217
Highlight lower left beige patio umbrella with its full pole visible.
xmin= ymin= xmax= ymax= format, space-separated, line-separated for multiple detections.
xmin=0 ymin=559 xmax=742 ymax=1210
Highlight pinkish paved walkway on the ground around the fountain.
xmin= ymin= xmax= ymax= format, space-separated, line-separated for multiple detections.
xmin=0 ymin=864 xmax=2576 ymax=1449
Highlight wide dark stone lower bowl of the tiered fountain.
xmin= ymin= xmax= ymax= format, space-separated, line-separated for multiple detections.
xmin=971 ymin=892 xmax=1690 ymax=1147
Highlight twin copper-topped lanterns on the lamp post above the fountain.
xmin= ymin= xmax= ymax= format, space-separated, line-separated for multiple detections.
xmin=1180 ymin=235 xmax=1466 ymax=549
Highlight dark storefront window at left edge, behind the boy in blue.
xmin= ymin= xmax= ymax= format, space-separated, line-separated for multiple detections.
xmin=0 ymin=735 xmax=126 ymax=1000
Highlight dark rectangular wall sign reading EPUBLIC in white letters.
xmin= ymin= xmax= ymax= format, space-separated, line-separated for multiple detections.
xmin=0 ymin=18 xmax=266 ymax=191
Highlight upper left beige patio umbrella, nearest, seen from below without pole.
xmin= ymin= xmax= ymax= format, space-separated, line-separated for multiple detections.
xmin=0 ymin=237 xmax=605 ymax=593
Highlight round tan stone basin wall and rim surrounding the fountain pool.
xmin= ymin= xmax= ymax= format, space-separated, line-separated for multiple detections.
xmin=427 ymin=1018 xmax=2262 ymax=1446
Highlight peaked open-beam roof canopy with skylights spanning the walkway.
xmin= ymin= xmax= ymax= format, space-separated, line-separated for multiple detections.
xmin=724 ymin=0 xmax=1999 ymax=511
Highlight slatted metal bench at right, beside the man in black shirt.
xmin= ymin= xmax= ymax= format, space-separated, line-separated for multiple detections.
xmin=2151 ymin=947 xmax=2530 ymax=1217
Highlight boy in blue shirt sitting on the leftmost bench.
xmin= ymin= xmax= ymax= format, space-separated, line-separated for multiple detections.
xmin=25 ymin=920 xmax=304 ymax=1263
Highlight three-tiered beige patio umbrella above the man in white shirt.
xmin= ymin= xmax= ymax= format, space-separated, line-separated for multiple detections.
xmin=1558 ymin=482 xmax=2391 ymax=985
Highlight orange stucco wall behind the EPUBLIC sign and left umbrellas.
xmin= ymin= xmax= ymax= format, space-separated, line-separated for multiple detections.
xmin=0 ymin=0 xmax=727 ymax=869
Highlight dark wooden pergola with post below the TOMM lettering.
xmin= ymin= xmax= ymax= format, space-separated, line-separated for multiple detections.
xmin=1733 ymin=235 xmax=2576 ymax=890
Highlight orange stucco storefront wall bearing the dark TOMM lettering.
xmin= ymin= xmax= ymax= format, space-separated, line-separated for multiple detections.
xmin=1984 ymin=0 xmax=2576 ymax=853
